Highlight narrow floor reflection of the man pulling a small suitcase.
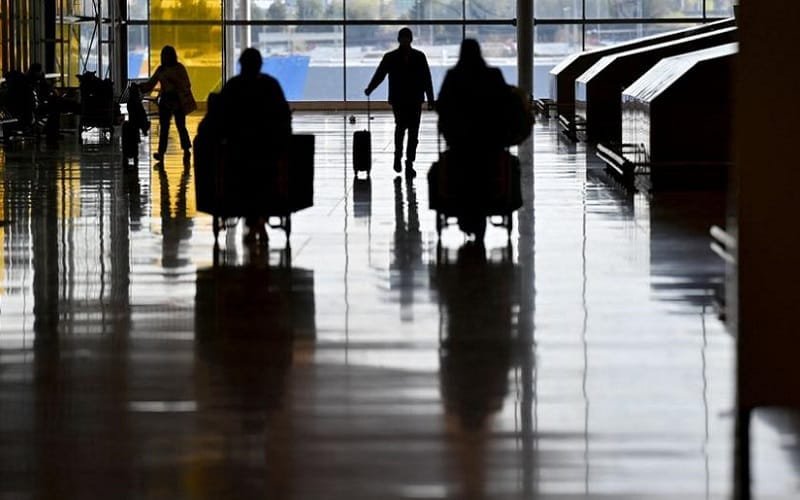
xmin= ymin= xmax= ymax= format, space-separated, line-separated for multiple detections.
xmin=390 ymin=177 xmax=422 ymax=321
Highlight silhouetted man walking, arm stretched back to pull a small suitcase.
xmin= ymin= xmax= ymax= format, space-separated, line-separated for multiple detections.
xmin=364 ymin=28 xmax=433 ymax=175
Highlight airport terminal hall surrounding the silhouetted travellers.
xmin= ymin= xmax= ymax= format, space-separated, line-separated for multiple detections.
xmin=0 ymin=0 xmax=800 ymax=500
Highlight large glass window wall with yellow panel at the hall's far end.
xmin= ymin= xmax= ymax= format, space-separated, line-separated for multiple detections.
xmin=90 ymin=0 xmax=733 ymax=101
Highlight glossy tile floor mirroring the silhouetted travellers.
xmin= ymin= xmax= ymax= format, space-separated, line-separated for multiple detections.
xmin=0 ymin=113 xmax=800 ymax=500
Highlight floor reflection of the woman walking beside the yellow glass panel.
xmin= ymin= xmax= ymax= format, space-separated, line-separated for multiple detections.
xmin=156 ymin=160 xmax=193 ymax=269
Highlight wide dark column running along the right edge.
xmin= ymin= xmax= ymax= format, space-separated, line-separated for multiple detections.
xmin=736 ymin=0 xmax=800 ymax=500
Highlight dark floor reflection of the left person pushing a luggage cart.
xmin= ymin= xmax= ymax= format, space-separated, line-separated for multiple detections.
xmin=194 ymin=252 xmax=316 ymax=498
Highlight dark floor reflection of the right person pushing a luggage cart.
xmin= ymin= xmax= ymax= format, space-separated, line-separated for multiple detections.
xmin=431 ymin=241 xmax=518 ymax=498
